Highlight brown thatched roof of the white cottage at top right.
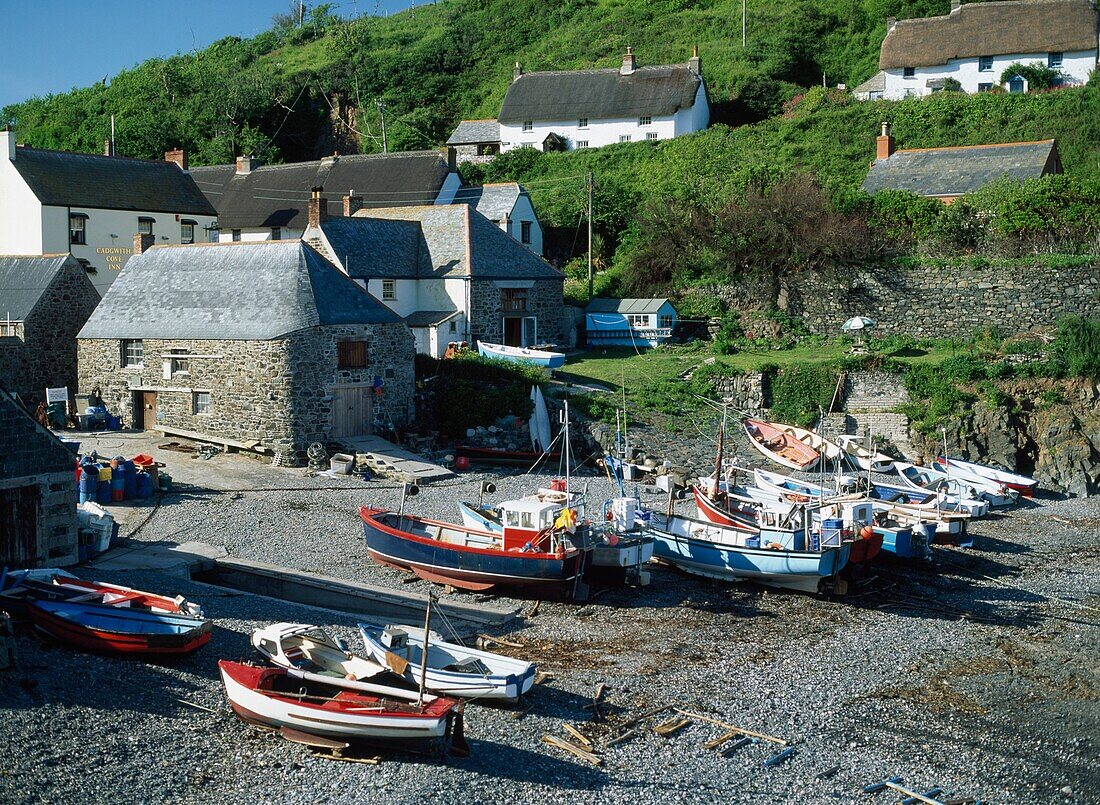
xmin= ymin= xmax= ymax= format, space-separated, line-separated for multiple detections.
xmin=879 ymin=0 xmax=1097 ymax=69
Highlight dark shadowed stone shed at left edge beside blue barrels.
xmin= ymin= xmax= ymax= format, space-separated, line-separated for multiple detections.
xmin=0 ymin=388 xmax=78 ymax=570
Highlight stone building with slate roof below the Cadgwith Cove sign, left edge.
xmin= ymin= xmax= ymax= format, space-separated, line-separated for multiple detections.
xmin=0 ymin=254 xmax=99 ymax=406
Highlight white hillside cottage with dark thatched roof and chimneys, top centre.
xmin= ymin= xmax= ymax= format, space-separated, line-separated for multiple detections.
xmin=497 ymin=47 xmax=711 ymax=152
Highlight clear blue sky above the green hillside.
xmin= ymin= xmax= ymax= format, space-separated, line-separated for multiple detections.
xmin=0 ymin=0 xmax=413 ymax=108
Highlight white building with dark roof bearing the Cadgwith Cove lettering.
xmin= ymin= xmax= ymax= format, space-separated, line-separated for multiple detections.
xmin=0 ymin=130 xmax=218 ymax=295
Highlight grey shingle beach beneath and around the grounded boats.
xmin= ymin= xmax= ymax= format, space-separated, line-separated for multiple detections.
xmin=0 ymin=435 xmax=1100 ymax=804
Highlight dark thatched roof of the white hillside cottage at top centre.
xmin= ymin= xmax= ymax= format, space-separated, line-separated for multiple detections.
xmin=497 ymin=65 xmax=702 ymax=123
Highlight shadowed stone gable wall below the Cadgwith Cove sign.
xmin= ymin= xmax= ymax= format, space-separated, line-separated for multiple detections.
xmin=0 ymin=258 xmax=99 ymax=406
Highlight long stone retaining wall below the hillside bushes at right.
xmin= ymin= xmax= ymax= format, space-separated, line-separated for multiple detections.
xmin=695 ymin=263 xmax=1100 ymax=338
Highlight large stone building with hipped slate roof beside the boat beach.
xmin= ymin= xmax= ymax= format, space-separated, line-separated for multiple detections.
xmin=78 ymin=241 xmax=414 ymax=460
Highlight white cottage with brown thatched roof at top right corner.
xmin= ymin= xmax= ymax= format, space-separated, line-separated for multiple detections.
xmin=871 ymin=0 xmax=1098 ymax=100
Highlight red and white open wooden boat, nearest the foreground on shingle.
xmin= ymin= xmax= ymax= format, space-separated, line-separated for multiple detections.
xmin=218 ymin=660 xmax=461 ymax=741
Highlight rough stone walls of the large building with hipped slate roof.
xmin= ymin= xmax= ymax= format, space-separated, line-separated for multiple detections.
xmin=79 ymin=322 xmax=414 ymax=460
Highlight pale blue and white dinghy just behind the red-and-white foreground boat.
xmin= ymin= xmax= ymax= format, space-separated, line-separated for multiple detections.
xmin=359 ymin=624 xmax=535 ymax=702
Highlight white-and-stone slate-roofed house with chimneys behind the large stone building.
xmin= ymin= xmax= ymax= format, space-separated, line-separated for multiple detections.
xmin=305 ymin=198 xmax=564 ymax=357
